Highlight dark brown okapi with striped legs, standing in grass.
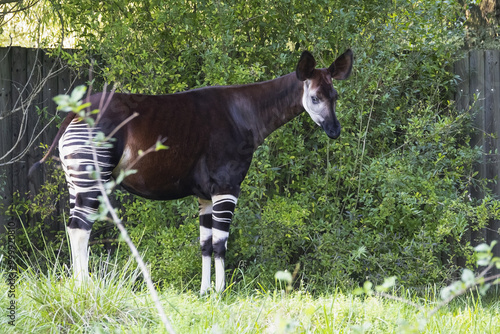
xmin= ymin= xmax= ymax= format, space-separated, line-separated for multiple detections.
xmin=32 ymin=49 xmax=353 ymax=294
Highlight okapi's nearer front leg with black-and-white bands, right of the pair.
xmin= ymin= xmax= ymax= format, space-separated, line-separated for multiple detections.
xmin=212 ymin=195 xmax=238 ymax=292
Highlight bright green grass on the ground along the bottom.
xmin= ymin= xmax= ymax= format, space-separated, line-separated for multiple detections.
xmin=0 ymin=259 xmax=500 ymax=333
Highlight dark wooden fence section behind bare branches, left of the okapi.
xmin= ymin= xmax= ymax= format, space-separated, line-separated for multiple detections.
xmin=0 ymin=47 xmax=85 ymax=233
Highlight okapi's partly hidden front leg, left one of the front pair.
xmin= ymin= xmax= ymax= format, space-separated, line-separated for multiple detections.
xmin=198 ymin=198 xmax=214 ymax=295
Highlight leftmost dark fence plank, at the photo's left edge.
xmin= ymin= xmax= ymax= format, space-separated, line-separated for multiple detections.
xmin=0 ymin=48 xmax=13 ymax=233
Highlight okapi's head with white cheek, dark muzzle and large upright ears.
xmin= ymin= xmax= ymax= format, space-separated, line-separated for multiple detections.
xmin=295 ymin=49 xmax=352 ymax=139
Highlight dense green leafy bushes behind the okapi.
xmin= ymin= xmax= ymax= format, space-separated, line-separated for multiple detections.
xmin=6 ymin=0 xmax=500 ymax=288
